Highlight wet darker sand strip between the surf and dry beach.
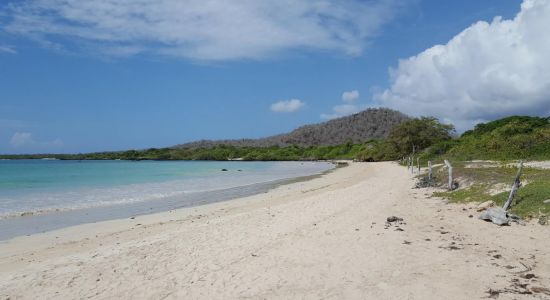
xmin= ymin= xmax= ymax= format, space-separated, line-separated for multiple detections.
xmin=0 ymin=164 xmax=343 ymax=241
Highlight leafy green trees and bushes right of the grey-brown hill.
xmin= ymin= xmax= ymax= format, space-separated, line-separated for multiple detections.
xmin=358 ymin=116 xmax=550 ymax=162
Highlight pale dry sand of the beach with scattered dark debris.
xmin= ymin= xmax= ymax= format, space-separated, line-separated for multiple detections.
xmin=0 ymin=163 xmax=550 ymax=299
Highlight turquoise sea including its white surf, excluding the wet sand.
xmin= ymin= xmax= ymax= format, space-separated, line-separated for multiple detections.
xmin=0 ymin=160 xmax=332 ymax=218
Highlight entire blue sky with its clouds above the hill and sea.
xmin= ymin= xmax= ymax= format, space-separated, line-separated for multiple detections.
xmin=0 ymin=0 xmax=550 ymax=153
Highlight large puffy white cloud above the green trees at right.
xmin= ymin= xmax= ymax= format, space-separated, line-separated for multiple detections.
xmin=375 ymin=0 xmax=550 ymax=130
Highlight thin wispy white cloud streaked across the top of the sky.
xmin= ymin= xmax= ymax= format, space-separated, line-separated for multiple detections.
xmin=0 ymin=0 xmax=403 ymax=60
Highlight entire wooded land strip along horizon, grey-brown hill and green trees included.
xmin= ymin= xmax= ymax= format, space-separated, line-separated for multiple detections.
xmin=0 ymin=113 xmax=550 ymax=164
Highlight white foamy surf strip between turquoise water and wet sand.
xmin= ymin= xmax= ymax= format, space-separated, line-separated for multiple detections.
xmin=0 ymin=162 xmax=333 ymax=219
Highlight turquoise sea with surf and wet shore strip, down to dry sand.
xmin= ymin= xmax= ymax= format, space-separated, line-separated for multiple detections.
xmin=0 ymin=160 xmax=333 ymax=240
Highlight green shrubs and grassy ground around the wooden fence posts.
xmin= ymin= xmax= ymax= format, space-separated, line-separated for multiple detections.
xmin=402 ymin=116 xmax=550 ymax=224
